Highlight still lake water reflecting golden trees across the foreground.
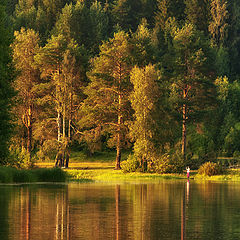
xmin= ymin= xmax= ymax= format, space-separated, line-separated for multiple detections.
xmin=0 ymin=180 xmax=240 ymax=240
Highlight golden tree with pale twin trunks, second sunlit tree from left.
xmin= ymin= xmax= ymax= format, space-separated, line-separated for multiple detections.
xmin=36 ymin=34 xmax=78 ymax=143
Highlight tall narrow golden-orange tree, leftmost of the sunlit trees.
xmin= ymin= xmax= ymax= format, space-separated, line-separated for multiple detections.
xmin=12 ymin=28 xmax=40 ymax=156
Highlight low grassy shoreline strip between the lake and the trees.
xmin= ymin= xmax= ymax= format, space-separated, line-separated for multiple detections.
xmin=0 ymin=163 xmax=240 ymax=184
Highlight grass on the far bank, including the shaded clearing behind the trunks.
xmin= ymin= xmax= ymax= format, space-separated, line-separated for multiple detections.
xmin=3 ymin=152 xmax=240 ymax=183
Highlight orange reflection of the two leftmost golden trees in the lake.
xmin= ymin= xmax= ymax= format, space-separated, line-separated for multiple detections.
xmin=7 ymin=185 xmax=68 ymax=240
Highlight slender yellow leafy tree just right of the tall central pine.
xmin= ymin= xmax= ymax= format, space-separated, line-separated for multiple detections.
xmin=130 ymin=65 xmax=160 ymax=165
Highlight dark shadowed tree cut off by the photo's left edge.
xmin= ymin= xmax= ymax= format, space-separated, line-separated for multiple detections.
xmin=0 ymin=1 xmax=13 ymax=164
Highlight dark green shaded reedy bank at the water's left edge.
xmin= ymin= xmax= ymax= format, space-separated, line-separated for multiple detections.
xmin=0 ymin=167 xmax=67 ymax=183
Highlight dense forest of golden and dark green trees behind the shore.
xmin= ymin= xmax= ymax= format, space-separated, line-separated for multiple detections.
xmin=0 ymin=0 xmax=240 ymax=172
